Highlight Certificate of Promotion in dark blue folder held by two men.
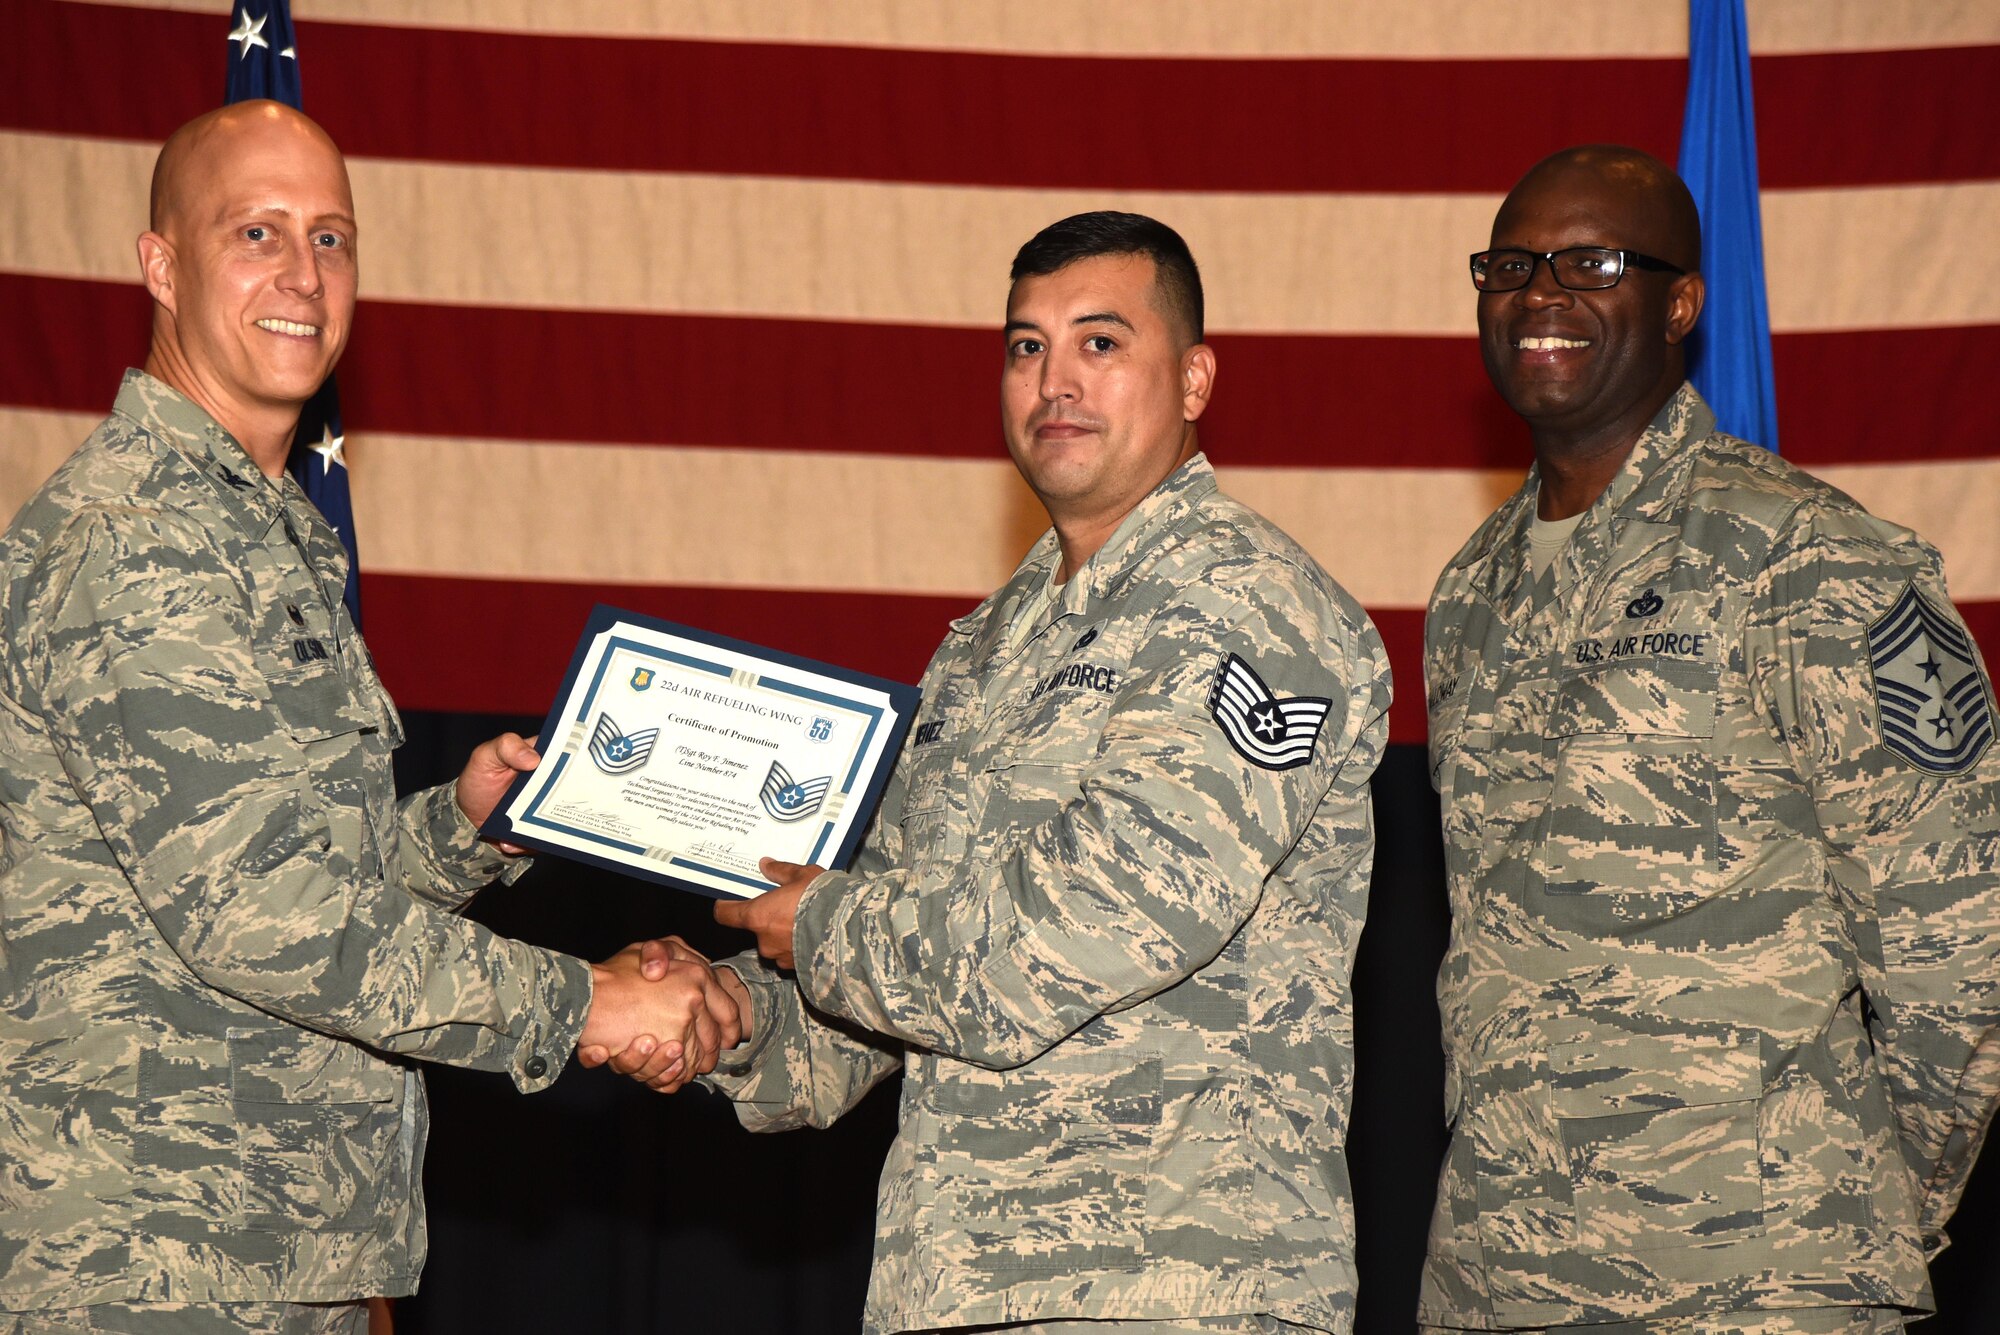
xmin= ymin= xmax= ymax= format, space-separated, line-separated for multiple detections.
xmin=480 ymin=606 xmax=918 ymax=897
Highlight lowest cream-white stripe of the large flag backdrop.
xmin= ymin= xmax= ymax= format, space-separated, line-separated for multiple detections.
xmin=0 ymin=409 xmax=2000 ymax=608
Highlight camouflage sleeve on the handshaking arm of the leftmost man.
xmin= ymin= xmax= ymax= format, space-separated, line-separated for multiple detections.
xmin=32 ymin=506 xmax=590 ymax=1089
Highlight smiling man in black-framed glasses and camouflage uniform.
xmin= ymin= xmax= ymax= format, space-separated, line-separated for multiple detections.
xmin=1420 ymin=148 xmax=2000 ymax=1335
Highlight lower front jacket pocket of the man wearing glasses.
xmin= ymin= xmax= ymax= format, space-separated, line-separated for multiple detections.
xmin=1550 ymin=1035 xmax=1764 ymax=1253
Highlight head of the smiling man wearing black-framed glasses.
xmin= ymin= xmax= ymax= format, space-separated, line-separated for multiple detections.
xmin=1478 ymin=156 xmax=1702 ymax=452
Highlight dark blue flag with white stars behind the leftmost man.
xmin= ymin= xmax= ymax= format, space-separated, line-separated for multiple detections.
xmin=222 ymin=0 xmax=362 ymax=626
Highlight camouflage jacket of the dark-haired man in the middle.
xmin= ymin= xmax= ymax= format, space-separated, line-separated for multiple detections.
xmin=712 ymin=456 xmax=1388 ymax=1331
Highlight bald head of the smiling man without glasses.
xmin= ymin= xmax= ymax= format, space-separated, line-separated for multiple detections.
xmin=140 ymin=102 xmax=356 ymax=466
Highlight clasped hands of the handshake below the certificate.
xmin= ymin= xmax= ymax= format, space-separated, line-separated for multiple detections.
xmin=576 ymin=945 xmax=740 ymax=1093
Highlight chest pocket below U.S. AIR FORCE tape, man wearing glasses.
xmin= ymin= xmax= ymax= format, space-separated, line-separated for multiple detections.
xmin=1534 ymin=662 xmax=1720 ymax=929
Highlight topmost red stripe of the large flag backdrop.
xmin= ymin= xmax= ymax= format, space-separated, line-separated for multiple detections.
xmin=0 ymin=0 xmax=2000 ymax=192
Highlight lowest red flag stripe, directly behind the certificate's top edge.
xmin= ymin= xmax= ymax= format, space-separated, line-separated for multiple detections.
xmin=362 ymin=572 xmax=1424 ymax=741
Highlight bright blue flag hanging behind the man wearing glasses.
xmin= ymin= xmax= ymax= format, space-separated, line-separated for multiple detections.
xmin=1680 ymin=0 xmax=1778 ymax=450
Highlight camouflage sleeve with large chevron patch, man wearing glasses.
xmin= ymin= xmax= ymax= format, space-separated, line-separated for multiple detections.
xmin=1746 ymin=504 xmax=2000 ymax=1253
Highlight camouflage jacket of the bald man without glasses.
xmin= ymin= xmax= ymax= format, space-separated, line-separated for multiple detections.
xmin=0 ymin=372 xmax=590 ymax=1309
